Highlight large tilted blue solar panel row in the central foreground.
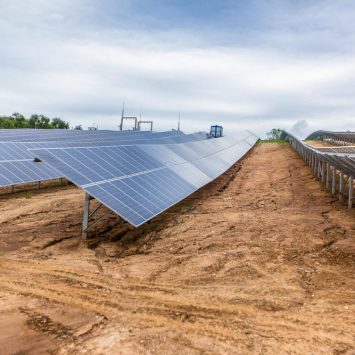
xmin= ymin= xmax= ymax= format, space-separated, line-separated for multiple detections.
xmin=31 ymin=131 xmax=258 ymax=227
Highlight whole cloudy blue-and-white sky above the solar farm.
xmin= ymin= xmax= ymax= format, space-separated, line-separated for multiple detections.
xmin=0 ymin=0 xmax=355 ymax=135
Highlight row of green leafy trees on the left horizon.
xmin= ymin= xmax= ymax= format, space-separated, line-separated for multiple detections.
xmin=0 ymin=112 xmax=71 ymax=129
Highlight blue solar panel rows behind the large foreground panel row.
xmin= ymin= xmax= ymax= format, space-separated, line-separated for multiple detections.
xmin=0 ymin=129 xmax=206 ymax=187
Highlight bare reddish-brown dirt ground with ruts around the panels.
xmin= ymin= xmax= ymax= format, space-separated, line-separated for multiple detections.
xmin=0 ymin=143 xmax=355 ymax=354
